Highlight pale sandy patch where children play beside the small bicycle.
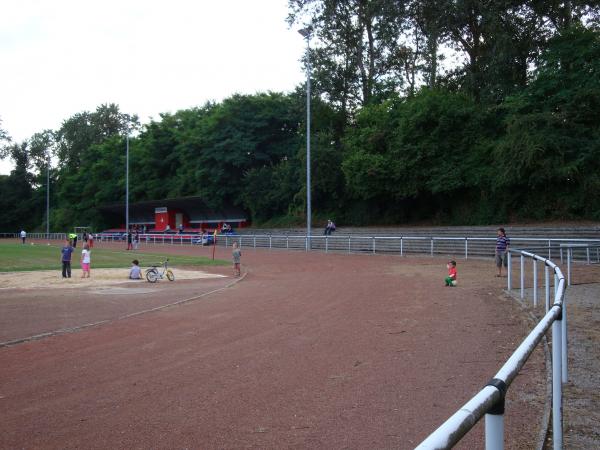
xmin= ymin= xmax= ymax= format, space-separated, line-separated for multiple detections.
xmin=0 ymin=269 xmax=224 ymax=289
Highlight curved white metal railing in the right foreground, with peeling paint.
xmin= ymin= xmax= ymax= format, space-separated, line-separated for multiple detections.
xmin=417 ymin=249 xmax=567 ymax=450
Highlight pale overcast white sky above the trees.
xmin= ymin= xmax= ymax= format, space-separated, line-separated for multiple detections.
xmin=0 ymin=0 xmax=306 ymax=173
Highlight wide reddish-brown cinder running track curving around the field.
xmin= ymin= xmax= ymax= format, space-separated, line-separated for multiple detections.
xmin=0 ymin=247 xmax=545 ymax=449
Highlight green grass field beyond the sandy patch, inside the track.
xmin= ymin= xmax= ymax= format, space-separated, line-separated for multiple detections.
xmin=0 ymin=241 xmax=229 ymax=272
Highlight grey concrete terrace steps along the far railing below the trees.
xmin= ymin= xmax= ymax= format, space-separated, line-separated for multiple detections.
xmin=225 ymin=226 xmax=600 ymax=260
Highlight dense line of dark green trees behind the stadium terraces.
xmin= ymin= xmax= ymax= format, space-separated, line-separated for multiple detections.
xmin=0 ymin=0 xmax=600 ymax=231
